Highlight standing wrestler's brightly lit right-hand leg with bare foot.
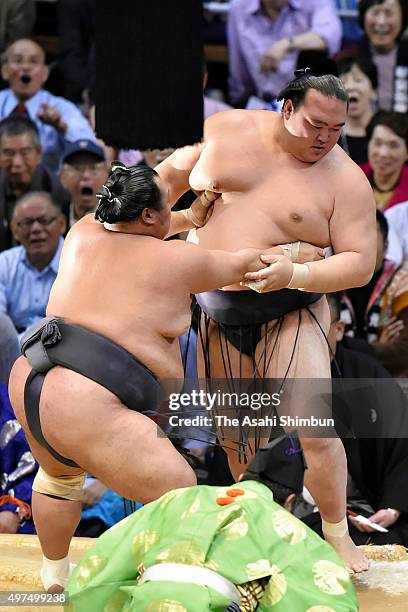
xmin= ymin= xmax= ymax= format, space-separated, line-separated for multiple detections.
xmin=257 ymin=298 xmax=368 ymax=571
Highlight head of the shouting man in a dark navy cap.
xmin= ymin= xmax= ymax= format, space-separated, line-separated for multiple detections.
xmin=61 ymin=139 xmax=109 ymax=227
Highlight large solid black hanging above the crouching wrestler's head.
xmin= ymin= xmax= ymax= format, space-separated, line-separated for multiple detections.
xmin=95 ymin=0 xmax=203 ymax=150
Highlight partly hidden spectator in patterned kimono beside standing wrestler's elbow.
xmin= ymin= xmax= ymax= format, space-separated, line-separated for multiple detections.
xmin=341 ymin=210 xmax=408 ymax=376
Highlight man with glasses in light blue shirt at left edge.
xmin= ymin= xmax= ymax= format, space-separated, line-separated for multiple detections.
xmin=0 ymin=191 xmax=66 ymax=381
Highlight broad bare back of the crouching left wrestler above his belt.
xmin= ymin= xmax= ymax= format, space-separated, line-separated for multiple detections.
xmin=47 ymin=215 xmax=198 ymax=378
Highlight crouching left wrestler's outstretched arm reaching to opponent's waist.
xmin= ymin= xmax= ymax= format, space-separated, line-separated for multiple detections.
xmin=167 ymin=240 xmax=265 ymax=293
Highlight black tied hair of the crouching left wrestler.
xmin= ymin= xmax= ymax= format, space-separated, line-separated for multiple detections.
xmin=95 ymin=161 xmax=162 ymax=223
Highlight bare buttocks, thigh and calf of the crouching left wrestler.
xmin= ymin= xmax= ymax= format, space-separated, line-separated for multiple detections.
xmin=9 ymin=358 xmax=196 ymax=588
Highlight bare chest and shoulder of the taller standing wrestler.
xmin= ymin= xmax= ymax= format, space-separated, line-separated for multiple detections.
xmin=190 ymin=111 xmax=353 ymax=250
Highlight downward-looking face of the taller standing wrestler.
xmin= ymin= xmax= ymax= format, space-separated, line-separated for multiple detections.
xmin=283 ymin=89 xmax=347 ymax=163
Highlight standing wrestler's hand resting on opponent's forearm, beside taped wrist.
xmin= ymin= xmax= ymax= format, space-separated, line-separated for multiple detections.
xmin=240 ymin=255 xmax=293 ymax=293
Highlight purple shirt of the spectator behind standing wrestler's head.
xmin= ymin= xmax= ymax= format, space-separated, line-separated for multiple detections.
xmin=227 ymin=0 xmax=342 ymax=102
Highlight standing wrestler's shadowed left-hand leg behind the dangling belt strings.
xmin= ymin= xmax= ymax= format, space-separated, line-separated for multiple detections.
xmin=197 ymin=321 xmax=268 ymax=481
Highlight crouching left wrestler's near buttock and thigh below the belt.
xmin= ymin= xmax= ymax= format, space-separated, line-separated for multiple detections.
xmin=9 ymin=360 xmax=195 ymax=503
